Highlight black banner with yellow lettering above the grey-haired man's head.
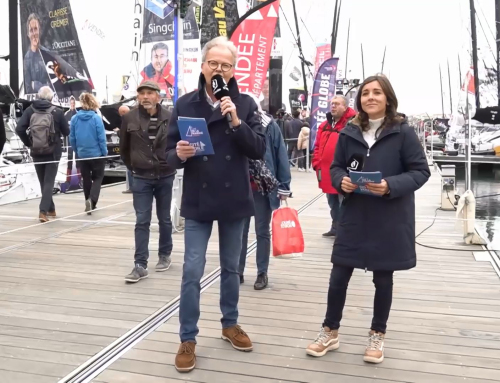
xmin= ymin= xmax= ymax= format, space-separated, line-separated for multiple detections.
xmin=200 ymin=0 xmax=238 ymax=49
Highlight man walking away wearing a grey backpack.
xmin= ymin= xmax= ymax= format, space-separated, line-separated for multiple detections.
xmin=16 ymin=86 xmax=69 ymax=223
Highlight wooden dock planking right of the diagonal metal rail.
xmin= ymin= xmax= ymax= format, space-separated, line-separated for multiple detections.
xmin=94 ymin=170 xmax=500 ymax=383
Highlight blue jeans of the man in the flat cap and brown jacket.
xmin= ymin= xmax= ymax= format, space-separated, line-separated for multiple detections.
xmin=132 ymin=176 xmax=174 ymax=268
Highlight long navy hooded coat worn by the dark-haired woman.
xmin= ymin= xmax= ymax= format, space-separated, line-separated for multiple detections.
xmin=330 ymin=120 xmax=430 ymax=270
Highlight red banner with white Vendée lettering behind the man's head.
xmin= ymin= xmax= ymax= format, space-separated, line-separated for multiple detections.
xmin=230 ymin=0 xmax=280 ymax=97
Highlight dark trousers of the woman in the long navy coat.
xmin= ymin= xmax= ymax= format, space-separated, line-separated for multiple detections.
xmin=323 ymin=265 xmax=394 ymax=334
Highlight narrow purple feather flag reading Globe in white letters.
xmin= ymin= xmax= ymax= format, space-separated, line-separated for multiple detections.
xmin=309 ymin=57 xmax=339 ymax=150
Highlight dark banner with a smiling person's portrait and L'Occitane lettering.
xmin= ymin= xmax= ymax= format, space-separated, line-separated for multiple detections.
xmin=19 ymin=0 xmax=94 ymax=105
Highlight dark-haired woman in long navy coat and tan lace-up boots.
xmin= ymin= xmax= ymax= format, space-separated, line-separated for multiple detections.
xmin=307 ymin=76 xmax=430 ymax=363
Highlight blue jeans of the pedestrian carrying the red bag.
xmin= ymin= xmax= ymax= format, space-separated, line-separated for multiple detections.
xmin=239 ymin=192 xmax=273 ymax=275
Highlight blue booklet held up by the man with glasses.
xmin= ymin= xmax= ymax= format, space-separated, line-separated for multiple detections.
xmin=177 ymin=117 xmax=214 ymax=156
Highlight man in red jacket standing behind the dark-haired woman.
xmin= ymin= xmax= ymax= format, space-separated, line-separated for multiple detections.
xmin=312 ymin=95 xmax=356 ymax=237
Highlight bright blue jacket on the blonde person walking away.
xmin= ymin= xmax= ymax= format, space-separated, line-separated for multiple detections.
xmin=69 ymin=110 xmax=108 ymax=158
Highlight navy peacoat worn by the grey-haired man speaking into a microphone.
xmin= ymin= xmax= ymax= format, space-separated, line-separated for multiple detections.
xmin=166 ymin=75 xmax=266 ymax=222
